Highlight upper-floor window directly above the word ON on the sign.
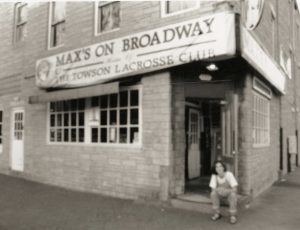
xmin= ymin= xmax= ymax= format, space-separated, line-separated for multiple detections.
xmin=96 ymin=1 xmax=121 ymax=34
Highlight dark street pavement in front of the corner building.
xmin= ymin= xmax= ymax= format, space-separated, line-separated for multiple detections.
xmin=0 ymin=168 xmax=300 ymax=230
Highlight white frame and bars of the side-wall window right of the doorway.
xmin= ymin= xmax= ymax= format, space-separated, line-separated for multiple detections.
xmin=252 ymin=90 xmax=271 ymax=148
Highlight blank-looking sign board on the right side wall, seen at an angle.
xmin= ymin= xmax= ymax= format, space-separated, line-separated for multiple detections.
xmin=241 ymin=27 xmax=286 ymax=93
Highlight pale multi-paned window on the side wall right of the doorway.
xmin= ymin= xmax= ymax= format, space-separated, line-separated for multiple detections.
xmin=253 ymin=92 xmax=270 ymax=147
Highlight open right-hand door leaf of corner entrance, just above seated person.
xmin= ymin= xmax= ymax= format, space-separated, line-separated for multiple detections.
xmin=222 ymin=93 xmax=238 ymax=177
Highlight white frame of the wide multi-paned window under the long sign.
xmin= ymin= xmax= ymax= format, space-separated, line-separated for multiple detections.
xmin=46 ymin=85 xmax=143 ymax=148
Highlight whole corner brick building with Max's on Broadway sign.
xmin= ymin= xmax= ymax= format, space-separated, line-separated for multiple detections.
xmin=0 ymin=0 xmax=300 ymax=200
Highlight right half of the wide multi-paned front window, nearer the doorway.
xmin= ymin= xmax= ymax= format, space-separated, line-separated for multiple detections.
xmin=91 ymin=89 xmax=140 ymax=144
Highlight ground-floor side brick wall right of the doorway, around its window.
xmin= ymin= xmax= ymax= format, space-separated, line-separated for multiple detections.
xmin=237 ymin=71 xmax=280 ymax=196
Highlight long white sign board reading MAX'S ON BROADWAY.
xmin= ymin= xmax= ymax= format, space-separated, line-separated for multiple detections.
xmin=36 ymin=13 xmax=236 ymax=88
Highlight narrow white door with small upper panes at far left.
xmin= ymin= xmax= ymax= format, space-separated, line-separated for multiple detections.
xmin=11 ymin=109 xmax=24 ymax=171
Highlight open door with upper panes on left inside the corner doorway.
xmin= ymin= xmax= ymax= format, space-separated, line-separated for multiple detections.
xmin=188 ymin=109 xmax=201 ymax=179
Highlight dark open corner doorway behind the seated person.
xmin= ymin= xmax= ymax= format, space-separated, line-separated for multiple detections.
xmin=185 ymin=94 xmax=237 ymax=193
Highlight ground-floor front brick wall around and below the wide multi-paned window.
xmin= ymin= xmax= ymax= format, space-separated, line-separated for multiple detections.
xmin=0 ymin=73 xmax=171 ymax=200
